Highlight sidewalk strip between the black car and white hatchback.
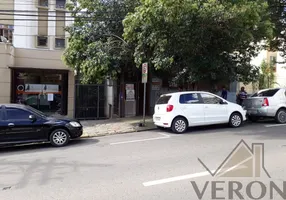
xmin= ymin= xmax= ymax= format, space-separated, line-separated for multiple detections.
xmin=81 ymin=117 xmax=156 ymax=137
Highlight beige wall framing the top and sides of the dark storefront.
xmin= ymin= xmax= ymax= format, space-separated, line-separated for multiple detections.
xmin=0 ymin=43 xmax=74 ymax=117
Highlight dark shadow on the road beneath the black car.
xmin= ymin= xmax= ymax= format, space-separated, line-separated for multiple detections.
xmin=0 ymin=138 xmax=99 ymax=156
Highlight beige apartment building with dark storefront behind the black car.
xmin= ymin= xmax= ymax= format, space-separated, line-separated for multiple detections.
xmin=0 ymin=0 xmax=74 ymax=117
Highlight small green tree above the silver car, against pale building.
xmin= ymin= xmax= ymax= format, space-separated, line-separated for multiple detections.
xmin=259 ymin=60 xmax=275 ymax=89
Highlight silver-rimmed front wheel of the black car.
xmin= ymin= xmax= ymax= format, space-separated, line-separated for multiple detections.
xmin=50 ymin=129 xmax=70 ymax=147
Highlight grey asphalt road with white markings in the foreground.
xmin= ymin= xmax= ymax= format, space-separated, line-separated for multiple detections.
xmin=0 ymin=122 xmax=286 ymax=200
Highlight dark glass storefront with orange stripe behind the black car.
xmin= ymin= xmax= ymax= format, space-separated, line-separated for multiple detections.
xmin=11 ymin=68 xmax=68 ymax=115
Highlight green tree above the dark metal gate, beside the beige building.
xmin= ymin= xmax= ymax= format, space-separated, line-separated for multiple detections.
xmin=63 ymin=0 xmax=138 ymax=83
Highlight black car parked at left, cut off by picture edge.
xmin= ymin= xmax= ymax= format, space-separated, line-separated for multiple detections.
xmin=0 ymin=104 xmax=83 ymax=147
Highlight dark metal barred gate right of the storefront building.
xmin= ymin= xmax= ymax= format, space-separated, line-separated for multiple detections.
xmin=75 ymin=84 xmax=107 ymax=120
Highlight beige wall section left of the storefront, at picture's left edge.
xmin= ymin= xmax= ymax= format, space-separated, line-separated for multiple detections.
xmin=0 ymin=43 xmax=14 ymax=103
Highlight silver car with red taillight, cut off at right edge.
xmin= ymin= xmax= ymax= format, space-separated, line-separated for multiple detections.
xmin=243 ymin=88 xmax=286 ymax=124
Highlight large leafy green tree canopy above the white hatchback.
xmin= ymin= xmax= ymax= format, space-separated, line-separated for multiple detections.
xmin=123 ymin=0 xmax=273 ymax=87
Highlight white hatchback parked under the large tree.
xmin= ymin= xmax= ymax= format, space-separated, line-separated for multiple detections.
xmin=153 ymin=91 xmax=246 ymax=133
